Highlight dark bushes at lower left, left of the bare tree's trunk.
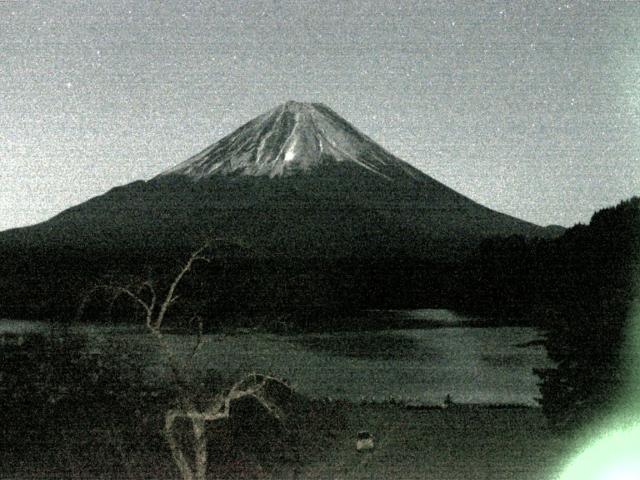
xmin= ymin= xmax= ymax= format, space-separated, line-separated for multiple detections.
xmin=0 ymin=326 xmax=155 ymax=464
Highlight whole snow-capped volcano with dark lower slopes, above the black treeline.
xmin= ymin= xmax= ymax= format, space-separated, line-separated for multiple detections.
xmin=0 ymin=101 xmax=557 ymax=259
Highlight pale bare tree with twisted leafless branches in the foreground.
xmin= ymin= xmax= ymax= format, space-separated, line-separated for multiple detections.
xmin=80 ymin=242 xmax=290 ymax=480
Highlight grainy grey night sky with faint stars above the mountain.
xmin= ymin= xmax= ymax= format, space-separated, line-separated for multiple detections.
xmin=0 ymin=0 xmax=640 ymax=230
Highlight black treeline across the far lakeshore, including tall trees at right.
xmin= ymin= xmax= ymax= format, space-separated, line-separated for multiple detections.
xmin=0 ymin=198 xmax=640 ymax=432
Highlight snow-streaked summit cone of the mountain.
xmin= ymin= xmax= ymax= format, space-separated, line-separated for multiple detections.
xmin=160 ymin=101 xmax=421 ymax=180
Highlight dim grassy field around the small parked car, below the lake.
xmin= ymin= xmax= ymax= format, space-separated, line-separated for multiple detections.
xmin=302 ymin=406 xmax=564 ymax=480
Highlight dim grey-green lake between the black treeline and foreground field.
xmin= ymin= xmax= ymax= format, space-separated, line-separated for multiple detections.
xmin=0 ymin=310 xmax=552 ymax=405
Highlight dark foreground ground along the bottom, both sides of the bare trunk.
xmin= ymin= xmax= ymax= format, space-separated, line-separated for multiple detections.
xmin=0 ymin=402 xmax=568 ymax=480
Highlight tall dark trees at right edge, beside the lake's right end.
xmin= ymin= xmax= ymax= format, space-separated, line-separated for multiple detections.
xmin=537 ymin=198 xmax=640 ymax=429
